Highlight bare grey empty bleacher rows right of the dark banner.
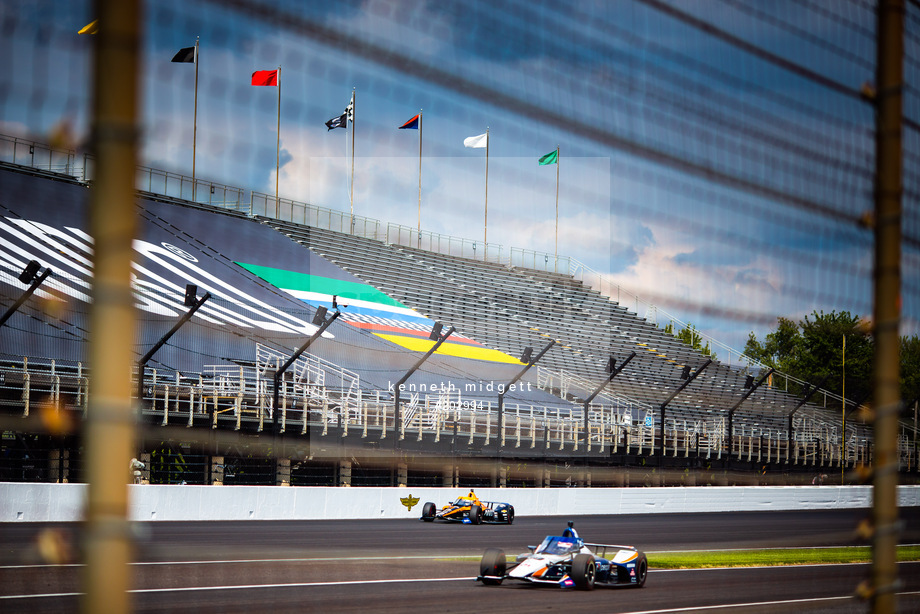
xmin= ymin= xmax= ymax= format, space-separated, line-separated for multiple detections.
xmin=259 ymin=212 xmax=867 ymax=462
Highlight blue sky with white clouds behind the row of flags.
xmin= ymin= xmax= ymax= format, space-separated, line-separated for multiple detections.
xmin=0 ymin=0 xmax=920 ymax=359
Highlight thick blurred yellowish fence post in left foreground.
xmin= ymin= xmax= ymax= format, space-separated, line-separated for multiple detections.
xmin=81 ymin=0 xmax=143 ymax=614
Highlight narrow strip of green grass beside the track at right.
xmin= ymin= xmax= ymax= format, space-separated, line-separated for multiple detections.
xmin=647 ymin=546 xmax=920 ymax=569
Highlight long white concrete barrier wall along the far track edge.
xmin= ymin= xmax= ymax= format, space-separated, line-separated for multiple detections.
xmin=0 ymin=482 xmax=920 ymax=522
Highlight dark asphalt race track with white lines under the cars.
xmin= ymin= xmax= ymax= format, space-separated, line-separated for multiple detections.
xmin=0 ymin=508 xmax=920 ymax=614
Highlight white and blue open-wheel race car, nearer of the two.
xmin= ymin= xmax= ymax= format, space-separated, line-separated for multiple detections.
xmin=476 ymin=522 xmax=648 ymax=590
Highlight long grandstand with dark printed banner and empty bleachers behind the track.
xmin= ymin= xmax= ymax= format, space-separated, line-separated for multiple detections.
xmin=0 ymin=143 xmax=917 ymax=485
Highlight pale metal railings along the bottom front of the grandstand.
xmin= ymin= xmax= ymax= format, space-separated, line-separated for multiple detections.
xmin=0 ymin=358 xmax=904 ymax=472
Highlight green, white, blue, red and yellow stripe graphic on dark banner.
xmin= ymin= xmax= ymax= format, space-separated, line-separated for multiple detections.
xmin=237 ymin=262 xmax=520 ymax=364
